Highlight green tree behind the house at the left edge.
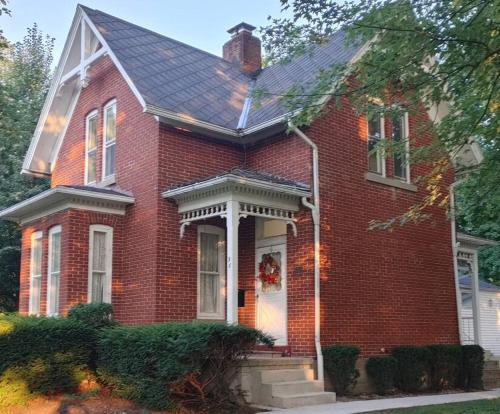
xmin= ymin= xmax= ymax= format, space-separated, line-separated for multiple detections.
xmin=0 ymin=25 xmax=54 ymax=310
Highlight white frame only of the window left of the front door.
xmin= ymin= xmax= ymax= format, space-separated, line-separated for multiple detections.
xmin=196 ymin=225 xmax=226 ymax=320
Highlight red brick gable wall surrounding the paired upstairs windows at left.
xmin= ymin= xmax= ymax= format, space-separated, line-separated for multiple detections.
xmin=52 ymin=58 xmax=160 ymax=323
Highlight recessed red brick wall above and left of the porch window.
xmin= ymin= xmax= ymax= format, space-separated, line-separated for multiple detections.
xmin=156 ymin=126 xmax=242 ymax=321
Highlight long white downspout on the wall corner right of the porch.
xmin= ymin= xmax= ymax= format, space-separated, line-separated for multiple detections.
xmin=289 ymin=123 xmax=324 ymax=381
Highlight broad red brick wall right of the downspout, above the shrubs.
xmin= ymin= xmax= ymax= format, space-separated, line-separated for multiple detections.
xmin=312 ymin=99 xmax=459 ymax=354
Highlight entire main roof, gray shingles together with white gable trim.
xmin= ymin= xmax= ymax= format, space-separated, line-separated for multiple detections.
xmin=23 ymin=5 xmax=359 ymax=175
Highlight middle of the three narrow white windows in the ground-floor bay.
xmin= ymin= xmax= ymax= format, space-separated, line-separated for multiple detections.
xmin=47 ymin=226 xmax=61 ymax=316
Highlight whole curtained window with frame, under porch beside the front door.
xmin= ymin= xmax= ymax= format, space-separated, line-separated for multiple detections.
xmin=198 ymin=226 xmax=225 ymax=319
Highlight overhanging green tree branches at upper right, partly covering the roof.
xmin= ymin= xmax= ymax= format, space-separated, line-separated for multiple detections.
xmin=260 ymin=0 xmax=500 ymax=228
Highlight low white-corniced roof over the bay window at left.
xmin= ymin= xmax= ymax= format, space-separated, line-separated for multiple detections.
xmin=0 ymin=185 xmax=135 ymax=224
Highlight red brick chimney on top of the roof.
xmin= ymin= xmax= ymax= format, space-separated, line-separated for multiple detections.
xmin=222 ymin=23 xmax=262 ymax=73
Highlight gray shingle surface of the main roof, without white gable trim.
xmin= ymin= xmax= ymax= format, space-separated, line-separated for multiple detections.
xmin=81 ymin=6 xmax=364 ymax=133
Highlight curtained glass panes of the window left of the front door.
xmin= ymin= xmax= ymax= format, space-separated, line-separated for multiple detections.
xmin=200 ymin=233 xmax=220 ymax=313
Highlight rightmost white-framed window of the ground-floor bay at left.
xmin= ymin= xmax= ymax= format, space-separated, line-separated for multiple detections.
xmin=88 ymin=224 xmax=113 ymax=303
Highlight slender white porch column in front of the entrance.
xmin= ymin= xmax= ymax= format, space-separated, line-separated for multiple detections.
xmin=226 ymin=200 xmax=240 ymax=324
